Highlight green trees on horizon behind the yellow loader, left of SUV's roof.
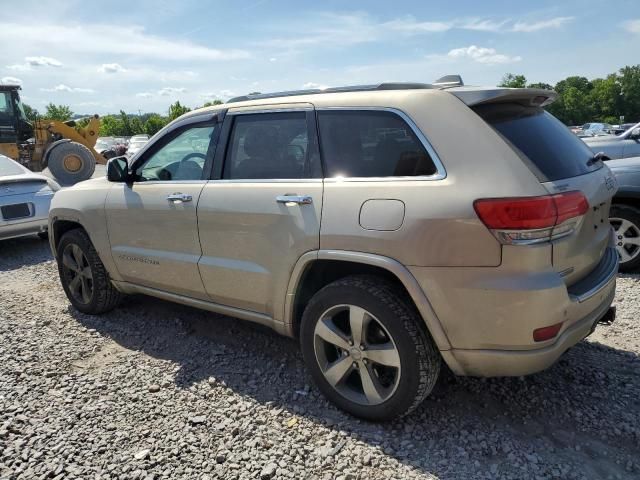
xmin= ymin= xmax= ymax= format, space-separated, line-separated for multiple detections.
xmin=23 ymin=100 xmax=222 ymax=137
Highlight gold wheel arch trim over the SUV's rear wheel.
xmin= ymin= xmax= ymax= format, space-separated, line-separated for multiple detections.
xmin=284 ymin=250 xmax=451 ymax=350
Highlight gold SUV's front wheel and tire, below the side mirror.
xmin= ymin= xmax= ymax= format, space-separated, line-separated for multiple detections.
xmin=57 ymin=229 xmax=122 ymax=315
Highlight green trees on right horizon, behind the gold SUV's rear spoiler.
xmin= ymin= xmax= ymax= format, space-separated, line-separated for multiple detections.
xmin=498 ymin=65 xmax=640 ymax=125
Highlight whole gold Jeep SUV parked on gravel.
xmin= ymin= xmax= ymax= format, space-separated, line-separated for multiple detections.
xmin=49 ymin=77 xmax=618 ymax=420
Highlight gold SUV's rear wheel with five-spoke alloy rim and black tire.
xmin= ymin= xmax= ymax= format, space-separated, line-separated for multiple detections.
xmin=300 ymin=275 xmax=441 ymax=421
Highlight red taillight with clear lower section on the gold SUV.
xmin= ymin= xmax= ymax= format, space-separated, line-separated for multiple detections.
xmin=473 ymin=192 xmax=589 ymax=243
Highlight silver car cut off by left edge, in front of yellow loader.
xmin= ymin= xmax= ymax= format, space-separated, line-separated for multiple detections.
xmin=0 ymin=155 xmax=60 ymax=240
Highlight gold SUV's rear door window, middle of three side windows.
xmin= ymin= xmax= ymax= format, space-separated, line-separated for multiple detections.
xmin=223 ymin=112 xmax=311 ymax=180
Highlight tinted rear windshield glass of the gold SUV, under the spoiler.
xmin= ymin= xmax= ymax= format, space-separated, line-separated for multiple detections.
xmin=474 ymin=103 xmax=602 ymax=182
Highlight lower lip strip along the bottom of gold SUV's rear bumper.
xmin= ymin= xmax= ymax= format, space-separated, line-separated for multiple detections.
xmin=445 ymin=278 xmax=615 ymax=377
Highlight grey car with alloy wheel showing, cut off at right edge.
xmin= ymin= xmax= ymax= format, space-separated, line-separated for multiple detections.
xmin=606 ymin=156 xmax=640 ymax=272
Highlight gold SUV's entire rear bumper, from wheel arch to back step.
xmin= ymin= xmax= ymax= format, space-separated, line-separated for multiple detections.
xmin=411 ymin=247 xmax=618 ymax=377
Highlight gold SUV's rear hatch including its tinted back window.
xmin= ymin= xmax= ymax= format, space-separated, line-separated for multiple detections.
xmin=473 ymin=101 xmax=616 ymax=286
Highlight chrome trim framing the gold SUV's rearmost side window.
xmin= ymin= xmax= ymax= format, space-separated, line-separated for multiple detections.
xmin=316 ymin=107 xmax=447 ymax=183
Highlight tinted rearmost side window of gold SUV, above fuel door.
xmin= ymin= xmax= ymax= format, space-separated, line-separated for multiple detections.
xmin=318 ymin=110 xmax=437 ymax=177
